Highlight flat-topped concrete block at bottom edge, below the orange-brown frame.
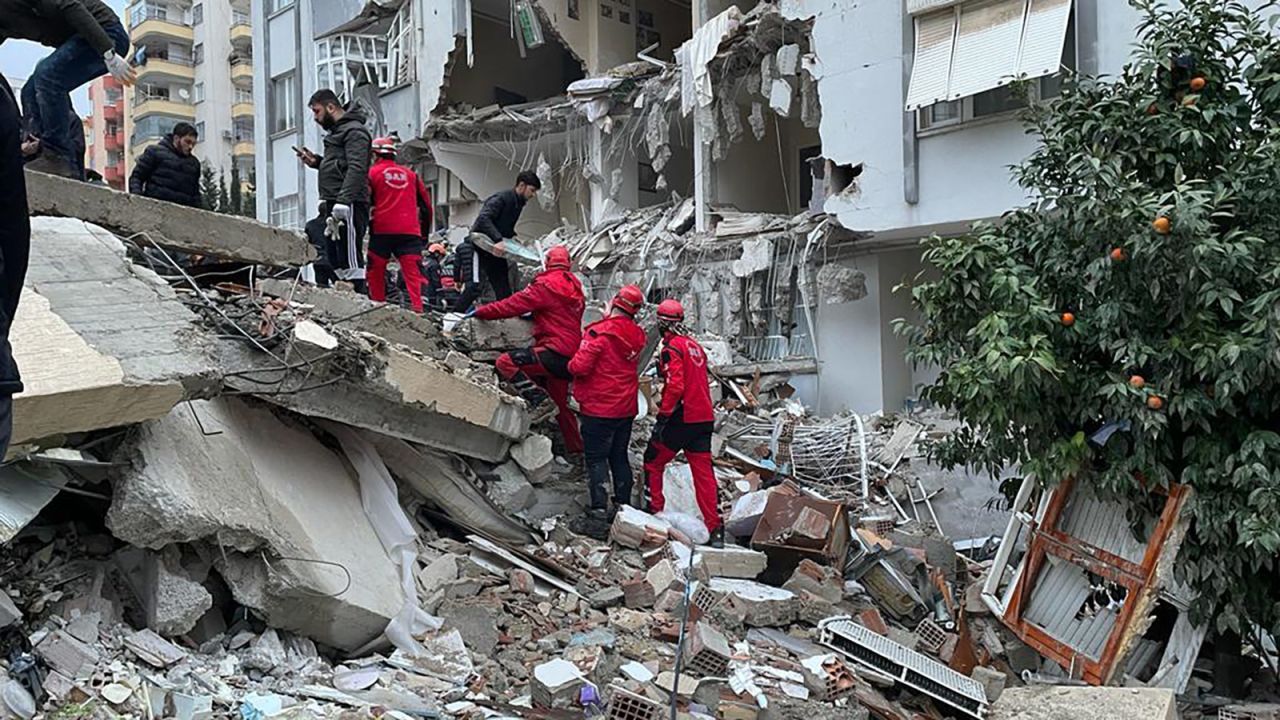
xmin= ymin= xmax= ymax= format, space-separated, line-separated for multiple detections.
xmin=987 ymin=685 xmax=1178 ymax=720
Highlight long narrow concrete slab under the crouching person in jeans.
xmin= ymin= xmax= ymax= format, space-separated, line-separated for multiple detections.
xmin=27 ymin=170 xmax=315 ymax=266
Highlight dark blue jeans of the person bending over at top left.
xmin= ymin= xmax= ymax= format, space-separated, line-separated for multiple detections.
xmin=22 ymin=23 xmax=129 ymax=169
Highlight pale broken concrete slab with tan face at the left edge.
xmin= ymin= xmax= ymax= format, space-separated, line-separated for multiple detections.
xmin=9 ymin=215 xmax=219 ymax=445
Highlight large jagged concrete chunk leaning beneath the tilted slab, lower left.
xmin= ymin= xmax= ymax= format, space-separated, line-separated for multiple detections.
xmin=106 ymin=398 xmax=403 ymax=651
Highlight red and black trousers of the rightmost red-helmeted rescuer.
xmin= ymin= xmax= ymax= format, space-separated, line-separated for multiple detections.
xmin=644 ymin=410 xmax=721 ymax=532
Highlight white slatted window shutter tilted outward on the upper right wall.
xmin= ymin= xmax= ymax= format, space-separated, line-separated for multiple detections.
xmin=906 ymin=0 xmax=1074 ymax=110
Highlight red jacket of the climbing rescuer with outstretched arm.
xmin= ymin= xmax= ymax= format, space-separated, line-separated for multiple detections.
xmin=476 ymin=270 xmax=586 ymax=357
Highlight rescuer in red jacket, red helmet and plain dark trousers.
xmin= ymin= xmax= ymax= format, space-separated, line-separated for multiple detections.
xmin=568 ymin=284 xmax=646 ymax=539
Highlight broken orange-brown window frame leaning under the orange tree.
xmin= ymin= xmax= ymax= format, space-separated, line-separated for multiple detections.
xmin=982 ymin=478 xmax=1190 ymax=684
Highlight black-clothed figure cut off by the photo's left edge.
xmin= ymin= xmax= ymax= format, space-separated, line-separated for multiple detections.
xmin=0 ymin=77 xmax=31 ymax=460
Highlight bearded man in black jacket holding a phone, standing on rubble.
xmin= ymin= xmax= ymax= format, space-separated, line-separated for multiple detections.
xmin=296 ymin=90 xmax=374 ymax=292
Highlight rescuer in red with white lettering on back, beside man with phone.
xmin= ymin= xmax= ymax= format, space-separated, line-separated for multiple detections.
xmin=366 ymin=137 xmax=431 ymax=313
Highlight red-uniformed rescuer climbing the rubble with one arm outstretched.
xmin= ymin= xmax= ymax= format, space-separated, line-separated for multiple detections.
xmin=474 ymin=245 xmax=586 ymax=454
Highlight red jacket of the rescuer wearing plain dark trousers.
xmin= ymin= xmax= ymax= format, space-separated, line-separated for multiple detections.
xmin=568 ymin=315 xmax=646 ymax=418
